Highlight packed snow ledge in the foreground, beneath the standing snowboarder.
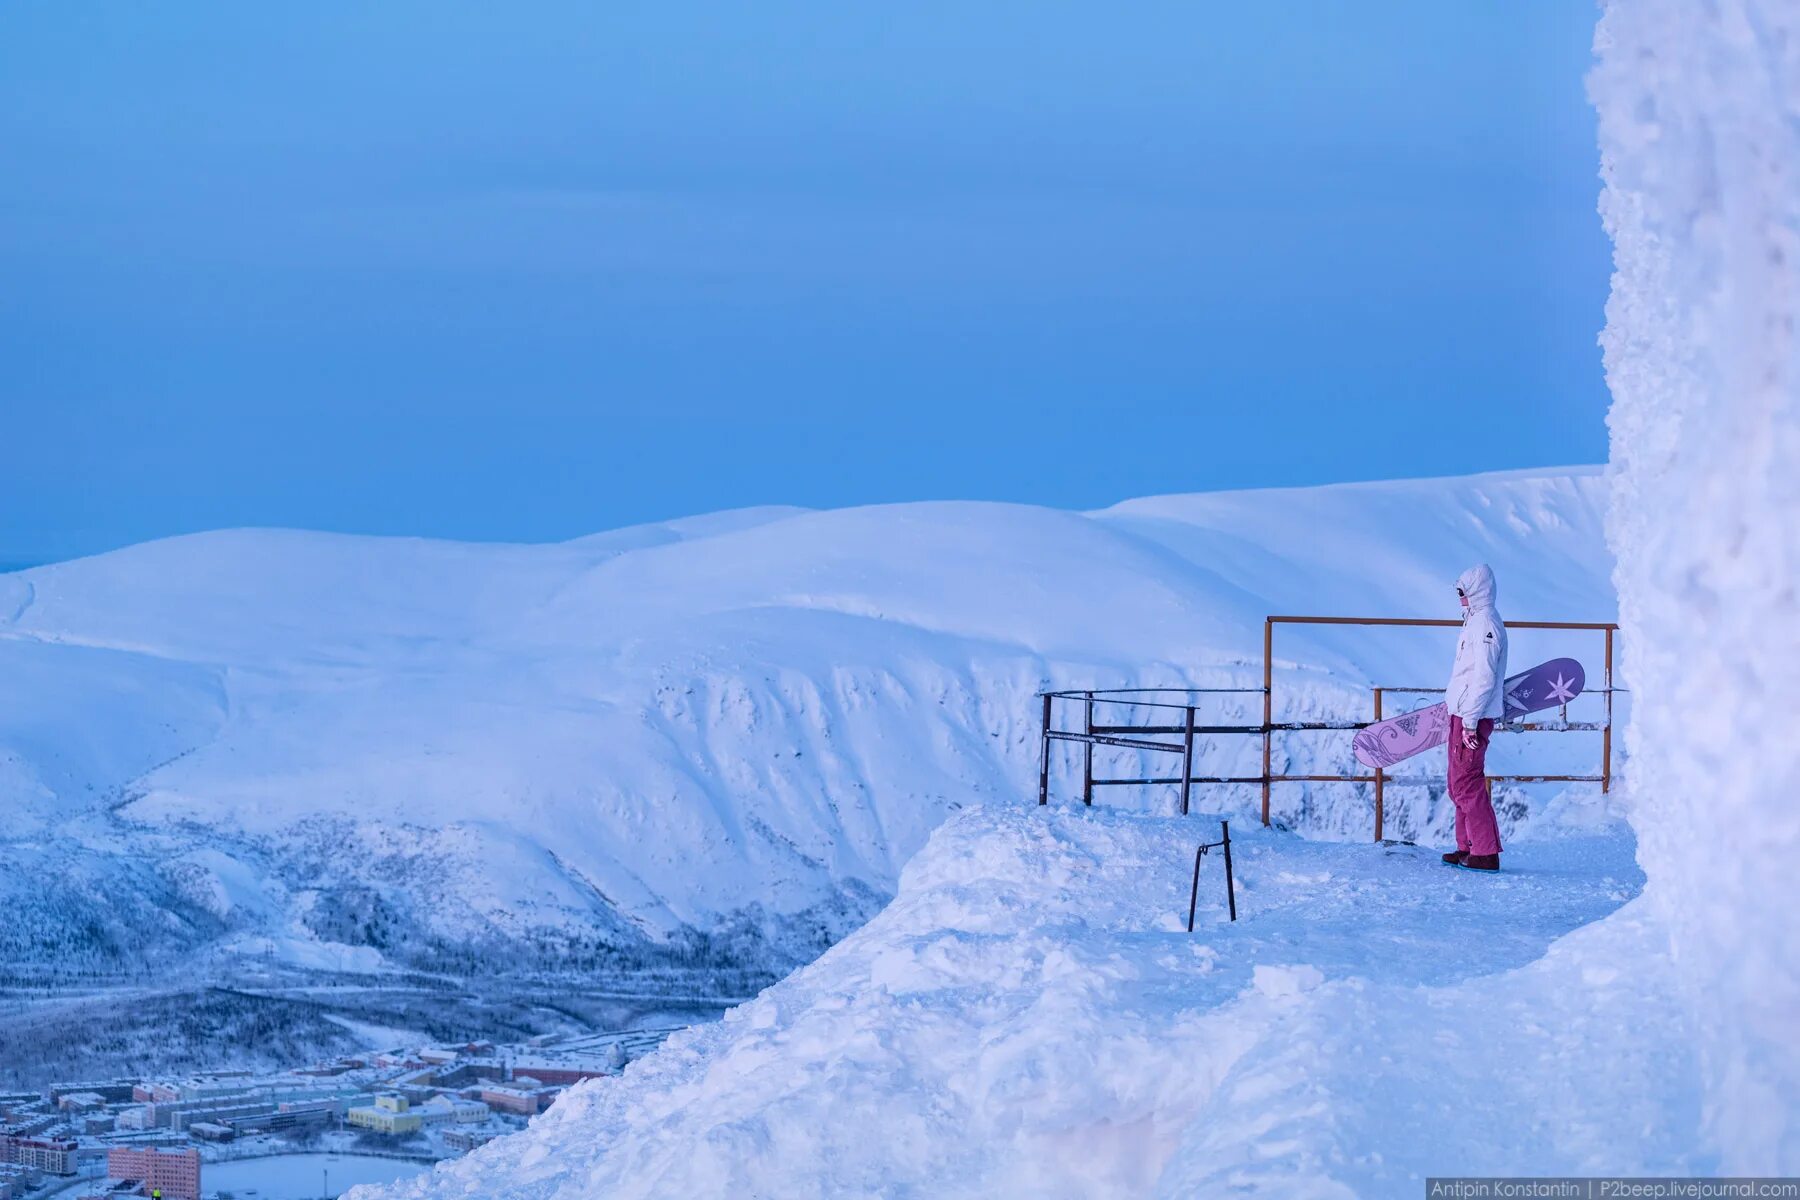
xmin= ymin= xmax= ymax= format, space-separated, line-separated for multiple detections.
xmin=353 ymin=804 xmax=1701 ymax=1200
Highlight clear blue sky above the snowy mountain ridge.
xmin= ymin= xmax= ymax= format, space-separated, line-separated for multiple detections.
xmin=0 ymin=0 xmax=1609 ymax=563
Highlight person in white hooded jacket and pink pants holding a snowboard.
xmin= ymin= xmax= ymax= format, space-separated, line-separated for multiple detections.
xmin=1444 ymin=563 xmax=1507 ymax=871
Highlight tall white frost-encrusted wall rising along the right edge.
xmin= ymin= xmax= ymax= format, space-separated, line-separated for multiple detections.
xmin=1589 ymin=0 xmax=1800 ymax=1173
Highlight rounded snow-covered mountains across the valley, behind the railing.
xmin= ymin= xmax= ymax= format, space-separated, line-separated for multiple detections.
xmin=0 ymin=470 xmax=1615 ymax=973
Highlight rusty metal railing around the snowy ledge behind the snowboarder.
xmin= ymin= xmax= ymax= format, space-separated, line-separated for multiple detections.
xmin=1037 ymin=615 xmax=1622 ymax=842
